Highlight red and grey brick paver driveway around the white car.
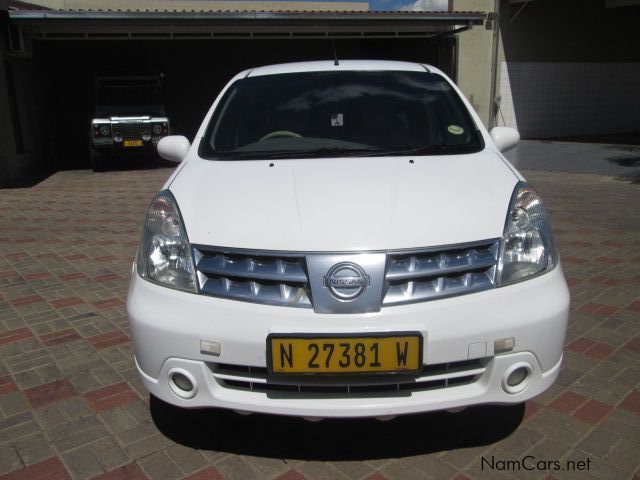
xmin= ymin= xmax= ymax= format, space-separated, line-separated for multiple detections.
xmin=0 ymin=169 xmax=640 ymax=480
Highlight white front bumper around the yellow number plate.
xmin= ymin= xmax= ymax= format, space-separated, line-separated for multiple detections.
xmin=127 ymin=266 xmax=569 ymax=418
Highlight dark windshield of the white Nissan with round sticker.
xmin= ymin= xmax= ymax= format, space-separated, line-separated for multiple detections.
xmin=199 ymin=71 xmax=483 ymax=160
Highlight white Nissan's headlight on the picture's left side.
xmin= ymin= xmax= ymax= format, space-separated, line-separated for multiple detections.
xmin=138 ymin=190 xmax=196 ymax=292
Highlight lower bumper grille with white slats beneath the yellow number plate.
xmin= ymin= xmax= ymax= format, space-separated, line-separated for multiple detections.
xmin=207 ymin=358 xmax=491 ymax=396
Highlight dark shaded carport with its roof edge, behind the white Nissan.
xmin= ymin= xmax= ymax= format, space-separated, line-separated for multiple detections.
xmin=1 ymin=12 xmax=484 ymax=186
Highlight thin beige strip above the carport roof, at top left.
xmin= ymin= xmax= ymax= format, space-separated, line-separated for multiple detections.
xmin=29 ymin=0 xmax=369 ymax=12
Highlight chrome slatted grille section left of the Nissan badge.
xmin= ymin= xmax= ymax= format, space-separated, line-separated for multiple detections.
xmin=194 ymin=247 xmax=312 ymax=308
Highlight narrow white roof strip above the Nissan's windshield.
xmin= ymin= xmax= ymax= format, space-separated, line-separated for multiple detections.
xmin=246 ymin=60 xmax=435 ymax=77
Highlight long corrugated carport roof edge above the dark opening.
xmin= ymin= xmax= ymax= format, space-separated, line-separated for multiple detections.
xmin=9 ymin=9 xmax=487 ymax=40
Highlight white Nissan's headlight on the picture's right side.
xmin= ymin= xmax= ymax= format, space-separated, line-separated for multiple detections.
xmin=498 ymin=182 xmax=558 ymax=285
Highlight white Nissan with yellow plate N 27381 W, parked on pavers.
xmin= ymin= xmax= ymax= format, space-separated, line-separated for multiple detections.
xmin=127 ymin=61 xmax=569 ymax=418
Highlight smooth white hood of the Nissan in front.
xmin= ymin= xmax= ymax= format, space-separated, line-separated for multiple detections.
xmin=170 ymin=150 xmax=518 ymax=252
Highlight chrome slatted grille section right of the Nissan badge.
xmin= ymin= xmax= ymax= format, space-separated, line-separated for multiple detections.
xmin=382 ymin=240 xmax=500 ymax=306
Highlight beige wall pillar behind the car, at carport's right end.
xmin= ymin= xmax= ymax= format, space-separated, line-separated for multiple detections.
xmin=453 ymin=0 xmax=495 ymax=126
